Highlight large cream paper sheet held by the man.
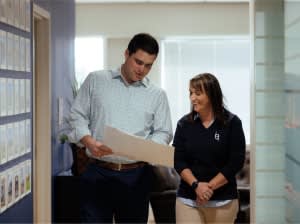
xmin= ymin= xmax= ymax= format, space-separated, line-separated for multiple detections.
xmin=103 ymin=126 xmax=174 ymax=167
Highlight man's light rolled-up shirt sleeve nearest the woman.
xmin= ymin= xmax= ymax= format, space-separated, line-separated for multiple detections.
xmin=150 ymin=91 xmax=173 ymax=144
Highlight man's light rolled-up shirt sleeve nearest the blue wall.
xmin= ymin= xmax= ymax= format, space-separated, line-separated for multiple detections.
xmin=67 ymin=73 xmax=93 ymax=145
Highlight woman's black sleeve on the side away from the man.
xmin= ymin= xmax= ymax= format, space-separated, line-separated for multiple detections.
xmin=220 ymin=116 xmax=246 ymax=180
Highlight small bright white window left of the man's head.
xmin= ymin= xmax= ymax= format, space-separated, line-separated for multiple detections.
xmin=75 ymin=37 xmax=104 ymax=86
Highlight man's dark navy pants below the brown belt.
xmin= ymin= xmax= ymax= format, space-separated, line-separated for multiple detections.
xmin=80 ymin=164 xmax=152 ymax=223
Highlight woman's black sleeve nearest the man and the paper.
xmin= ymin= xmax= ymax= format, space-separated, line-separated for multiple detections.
xmin=173 ymin=121 xmax=188 ymax=175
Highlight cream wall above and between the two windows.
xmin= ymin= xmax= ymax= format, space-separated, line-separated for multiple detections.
xmin=76 ymin=3 xmax=249 ymax=85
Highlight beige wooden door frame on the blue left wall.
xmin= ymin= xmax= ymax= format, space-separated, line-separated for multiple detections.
xmin=33 ymin=4 xmax=52 ymax=223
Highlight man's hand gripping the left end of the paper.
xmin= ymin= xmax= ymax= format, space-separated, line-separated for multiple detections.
xmin=81 ymin=136 xmax=113 ymax=157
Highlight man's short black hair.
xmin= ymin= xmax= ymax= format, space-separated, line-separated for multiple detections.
xmin=127 ymin=33 xmax=159 ymax=55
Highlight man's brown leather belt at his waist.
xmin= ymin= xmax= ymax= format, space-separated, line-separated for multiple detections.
xmin=90 ymin=158 xmax=147 ymax=171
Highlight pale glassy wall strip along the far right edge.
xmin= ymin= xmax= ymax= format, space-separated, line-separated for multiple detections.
xmin=284 ymin=0 xmax=300 ymax=223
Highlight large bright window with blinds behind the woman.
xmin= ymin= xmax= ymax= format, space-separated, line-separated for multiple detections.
xmin=161 ymin=37 xmax=250 ymax=144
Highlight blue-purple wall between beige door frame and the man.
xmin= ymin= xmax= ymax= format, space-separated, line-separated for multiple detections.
xmin=34 ymin=0 xmax=75 ymax=176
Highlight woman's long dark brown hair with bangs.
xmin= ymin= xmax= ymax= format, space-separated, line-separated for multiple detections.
xmin=189 ymin=73 xmax=228 ymax=125
